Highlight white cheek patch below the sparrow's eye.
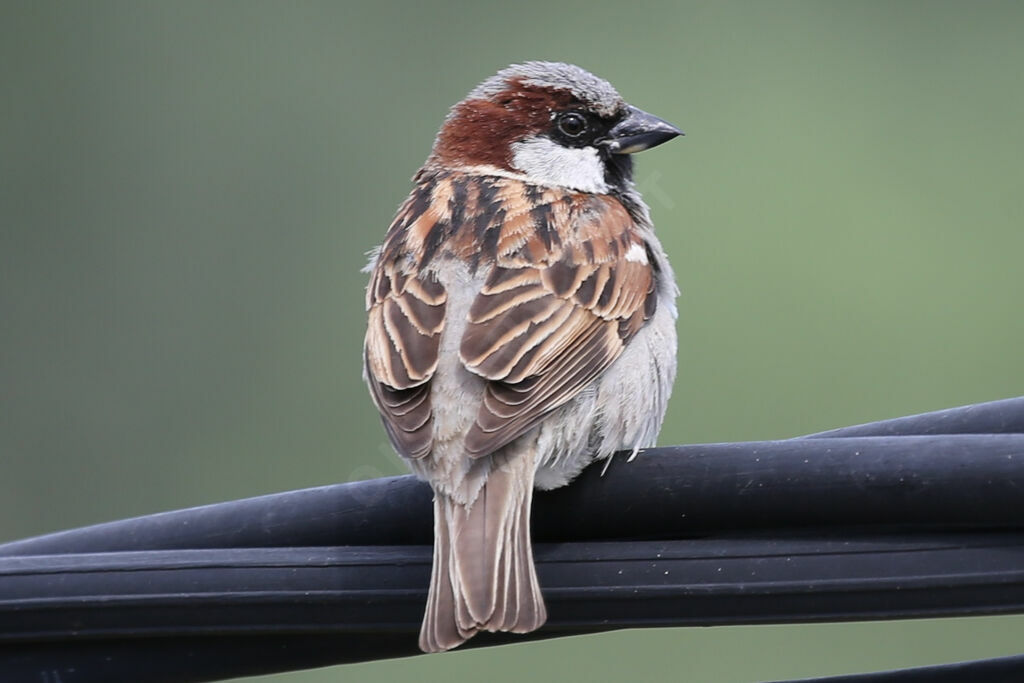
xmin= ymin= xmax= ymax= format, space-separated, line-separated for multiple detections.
xmin=512 ymin=136 xmax=608 ymax=193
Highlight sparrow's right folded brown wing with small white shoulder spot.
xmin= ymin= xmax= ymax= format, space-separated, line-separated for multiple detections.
xmin=460 ymin=197 xmax=657 ymax=457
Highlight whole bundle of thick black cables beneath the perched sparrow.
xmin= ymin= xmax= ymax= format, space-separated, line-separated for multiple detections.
xmin=0 ymin=398 xmax=1024 ymax=683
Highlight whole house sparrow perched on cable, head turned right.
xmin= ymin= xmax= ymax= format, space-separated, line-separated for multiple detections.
xmin=365 ymin=61 xmax=682 ymax=652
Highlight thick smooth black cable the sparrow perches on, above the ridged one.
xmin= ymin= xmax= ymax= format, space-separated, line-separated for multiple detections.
xmin=0 ymin=436 xmax=1024 ymax=557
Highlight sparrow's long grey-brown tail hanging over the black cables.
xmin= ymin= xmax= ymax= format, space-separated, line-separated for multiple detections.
xmin=420 ymin=453 xmax=548 ymax=652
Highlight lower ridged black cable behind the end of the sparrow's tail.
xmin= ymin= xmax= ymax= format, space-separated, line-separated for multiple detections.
xmin=6 ymin=532 xmax=1024 ymax=683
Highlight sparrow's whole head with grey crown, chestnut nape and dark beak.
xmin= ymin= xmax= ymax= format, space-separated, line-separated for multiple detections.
xmin=428 ymin=61 xmax=682 ymax=193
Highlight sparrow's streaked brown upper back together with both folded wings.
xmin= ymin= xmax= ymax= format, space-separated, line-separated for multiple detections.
xmin=365 ymin=170 xmax=657 ymax=466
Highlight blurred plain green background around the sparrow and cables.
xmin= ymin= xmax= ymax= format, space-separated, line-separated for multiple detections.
xmin=0 ymin=0 xmax=1024 ymax=683
